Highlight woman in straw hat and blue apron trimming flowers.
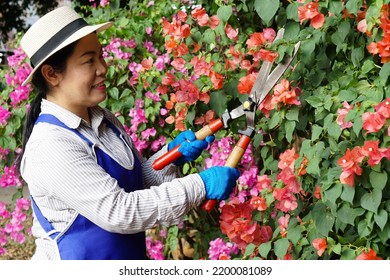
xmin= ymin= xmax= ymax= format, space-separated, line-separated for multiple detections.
xmin=20 ymin=7 xmax=239 ymax=259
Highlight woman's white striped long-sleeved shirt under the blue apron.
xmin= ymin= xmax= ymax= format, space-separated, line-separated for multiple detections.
xmin=21 ymin=99 xmax=205 ymax=259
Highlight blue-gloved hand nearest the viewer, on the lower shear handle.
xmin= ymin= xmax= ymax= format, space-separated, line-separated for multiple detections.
xmin=199 ymin=166 xmax=240 ymax=200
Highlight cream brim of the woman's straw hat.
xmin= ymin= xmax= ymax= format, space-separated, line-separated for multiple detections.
xmin=22 ymin=21 xmax=114 ymax=86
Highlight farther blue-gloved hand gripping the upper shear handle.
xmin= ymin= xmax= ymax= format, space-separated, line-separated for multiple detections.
xmin=168 ymin=130 xmax=215 ymax=165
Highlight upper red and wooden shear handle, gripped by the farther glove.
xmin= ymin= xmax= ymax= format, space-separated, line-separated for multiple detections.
xmin=152 ymin=119 xmax=223 ymax=170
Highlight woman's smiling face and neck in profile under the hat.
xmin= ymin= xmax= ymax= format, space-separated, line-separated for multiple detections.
xmin=47 ymin=33 xmax=107 ymax=121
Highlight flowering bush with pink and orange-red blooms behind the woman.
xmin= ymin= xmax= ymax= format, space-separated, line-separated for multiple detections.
xmin=0 ymin=0 xmax=390 ymax=259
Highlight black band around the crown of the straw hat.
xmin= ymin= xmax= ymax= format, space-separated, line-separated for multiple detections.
xmin=30 ymin=18 xmax=88 ymax=68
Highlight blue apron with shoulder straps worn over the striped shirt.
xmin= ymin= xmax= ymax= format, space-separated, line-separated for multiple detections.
xmin=31 ymin=114 xmax=146 ymax=260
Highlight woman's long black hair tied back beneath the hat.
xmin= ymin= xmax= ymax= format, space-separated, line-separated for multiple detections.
xmin=16 ymin=42 xmax=76 ymax=169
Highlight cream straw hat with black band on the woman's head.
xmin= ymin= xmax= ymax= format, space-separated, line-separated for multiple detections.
xmin=20 ymin=6 xmax=113 ymax=85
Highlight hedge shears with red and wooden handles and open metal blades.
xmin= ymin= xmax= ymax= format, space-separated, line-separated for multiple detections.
xmin=152 ymin=29 xmax=300 ymax=212
